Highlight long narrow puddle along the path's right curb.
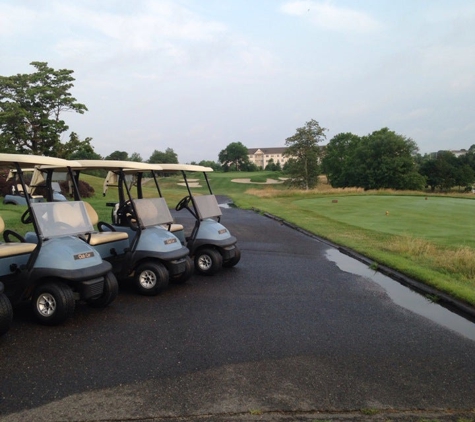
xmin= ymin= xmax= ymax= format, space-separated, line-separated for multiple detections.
xmin=326 ymin=248 xmax=475 ymax=341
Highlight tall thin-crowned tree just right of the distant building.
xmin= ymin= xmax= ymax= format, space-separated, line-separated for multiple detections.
xmin=284 ymin=119 xmax=327 ymax=189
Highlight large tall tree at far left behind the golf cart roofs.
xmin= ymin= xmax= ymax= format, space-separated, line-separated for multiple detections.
xmin=0 ymin=62 xmax=87 ymax=155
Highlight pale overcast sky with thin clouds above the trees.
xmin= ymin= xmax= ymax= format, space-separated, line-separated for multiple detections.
xmin=0 ymin=0 xmax=475 ymax=163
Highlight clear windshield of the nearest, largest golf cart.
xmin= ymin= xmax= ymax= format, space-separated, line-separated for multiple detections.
xmin=31 ymin=201 xmax=94 ymax=238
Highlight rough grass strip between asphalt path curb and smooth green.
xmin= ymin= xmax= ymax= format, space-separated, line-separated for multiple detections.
xmin=232 ymin=189 xmax=475 ymax=307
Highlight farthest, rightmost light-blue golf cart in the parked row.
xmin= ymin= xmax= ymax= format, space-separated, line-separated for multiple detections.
xmin=156 ymin=164 xmax=241 ymax=275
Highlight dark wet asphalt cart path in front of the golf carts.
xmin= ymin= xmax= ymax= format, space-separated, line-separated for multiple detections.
xmin=0 ymin=204 xmax=475 ymax=422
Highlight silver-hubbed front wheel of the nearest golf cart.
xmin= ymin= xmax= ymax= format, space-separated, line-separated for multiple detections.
xmin=32 ymin=282 xmax=76 ymax=325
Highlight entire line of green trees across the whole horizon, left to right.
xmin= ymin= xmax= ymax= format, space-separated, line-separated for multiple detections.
xmin=0 ymin=62 xmax=475 ymax=191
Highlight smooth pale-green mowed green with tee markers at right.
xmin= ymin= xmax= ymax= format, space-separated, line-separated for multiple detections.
xmin=294 ymin=195 xmax=475 ymax=249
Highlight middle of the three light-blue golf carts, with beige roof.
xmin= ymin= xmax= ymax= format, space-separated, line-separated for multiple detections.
xmin=59 ymin=160 xmax=193 ymax=296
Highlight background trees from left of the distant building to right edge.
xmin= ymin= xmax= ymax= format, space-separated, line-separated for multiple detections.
xmin=219 ymin=119 xmax=475 ymax=192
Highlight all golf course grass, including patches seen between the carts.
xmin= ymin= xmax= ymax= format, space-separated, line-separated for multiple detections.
xmin=0 ymin=172 xmax=475 ymax=306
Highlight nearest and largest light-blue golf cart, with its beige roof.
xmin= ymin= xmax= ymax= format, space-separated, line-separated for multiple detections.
xmin=0 ymin=154 xmax=118 ymax=325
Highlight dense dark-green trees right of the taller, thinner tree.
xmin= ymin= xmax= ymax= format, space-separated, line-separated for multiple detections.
xmin=322 ymin=128 xmax=475 ymax=191
